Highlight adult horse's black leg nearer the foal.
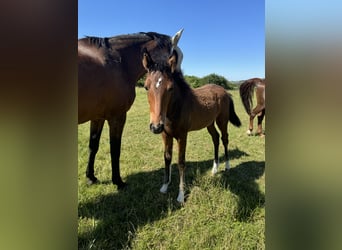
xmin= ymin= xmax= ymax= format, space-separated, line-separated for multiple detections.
xmin=108 ymin=113 xmax=126 ymax=189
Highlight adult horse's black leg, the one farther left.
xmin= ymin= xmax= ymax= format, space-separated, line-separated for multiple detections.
xmin=86 ymin=120 xmax=104 ymax=184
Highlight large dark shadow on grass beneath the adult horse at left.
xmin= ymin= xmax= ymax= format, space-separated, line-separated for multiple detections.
xmin=78 ymin=169 xmax=180 ymax=249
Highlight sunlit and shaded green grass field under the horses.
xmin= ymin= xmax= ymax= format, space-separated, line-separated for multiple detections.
xmin=78 ymin=88 xmax=265 ymax=249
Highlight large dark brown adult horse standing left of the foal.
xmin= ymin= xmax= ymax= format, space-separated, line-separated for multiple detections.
xmin=78 ymin=30 xmax=182 ymax=188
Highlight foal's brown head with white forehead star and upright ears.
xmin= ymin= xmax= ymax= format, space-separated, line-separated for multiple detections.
xmin=143 ymin=51 xmax=178 ymax=134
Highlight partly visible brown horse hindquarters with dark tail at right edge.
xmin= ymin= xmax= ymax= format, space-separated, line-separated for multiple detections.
xmin=239 ymin=78 xmax=266 ymax=136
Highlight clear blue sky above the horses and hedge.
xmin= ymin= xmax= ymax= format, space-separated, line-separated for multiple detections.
xmin=78 ymin=0 xmax=265 ymax=81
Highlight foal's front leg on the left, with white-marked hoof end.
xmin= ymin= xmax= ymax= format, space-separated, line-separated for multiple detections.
xmin=160 ymin=132 xmax=173 ymax=193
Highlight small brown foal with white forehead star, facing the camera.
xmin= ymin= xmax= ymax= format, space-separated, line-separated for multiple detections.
xmin=143 ymin=50 xmax=241 ymax=203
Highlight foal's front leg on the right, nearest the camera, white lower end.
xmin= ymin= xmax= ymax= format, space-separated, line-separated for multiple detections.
xmin=177 ymin=134 xmax=187 ymax=203
